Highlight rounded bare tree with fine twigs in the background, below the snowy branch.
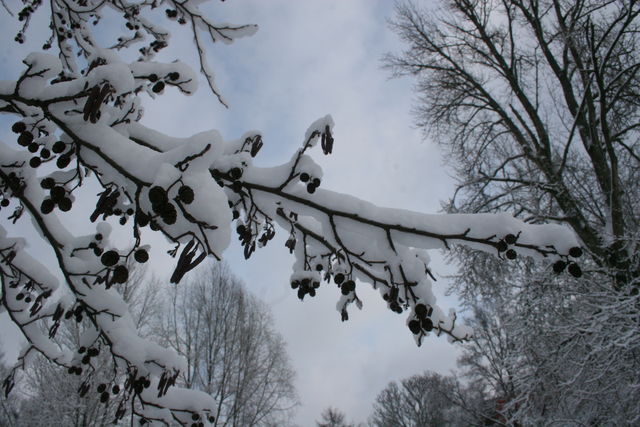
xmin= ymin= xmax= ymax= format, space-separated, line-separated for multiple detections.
xmin=163 ymin=263 xmax=297 ymax=426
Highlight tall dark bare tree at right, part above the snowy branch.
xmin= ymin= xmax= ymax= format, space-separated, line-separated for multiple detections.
xmin=388 ymin=0 xmax=640 ymax=286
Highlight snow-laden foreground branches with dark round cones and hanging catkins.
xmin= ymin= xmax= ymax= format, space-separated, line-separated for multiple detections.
xmin=0 ymin=0 xmax=581 ymax=424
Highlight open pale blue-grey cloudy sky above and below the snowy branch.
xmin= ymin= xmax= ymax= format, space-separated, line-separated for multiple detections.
xmin=0 ymin=0 xmax=457 ymax=426
